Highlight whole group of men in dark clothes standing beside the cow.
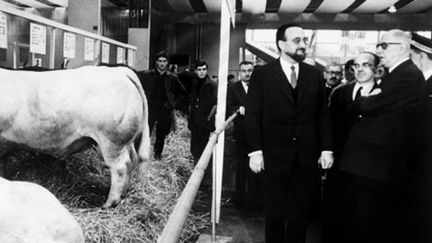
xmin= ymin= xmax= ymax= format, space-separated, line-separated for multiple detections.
xmin=141 ymin=24 xmax=432 ymax=243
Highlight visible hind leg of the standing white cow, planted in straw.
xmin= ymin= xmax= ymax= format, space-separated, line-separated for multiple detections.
xmin=100 ymin=145 xmax=132 ymax=208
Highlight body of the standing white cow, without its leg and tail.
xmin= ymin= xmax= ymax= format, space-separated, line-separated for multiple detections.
xmin=0 ymin=66 xmax=144 ymax=154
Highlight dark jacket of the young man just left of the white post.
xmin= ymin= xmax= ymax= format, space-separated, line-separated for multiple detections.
xmin=188 ymin=76 xmax=217 ymax=131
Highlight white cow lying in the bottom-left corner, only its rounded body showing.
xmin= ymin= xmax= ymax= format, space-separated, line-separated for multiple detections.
xmin=0 ymin=177 xmax=84 ymax=243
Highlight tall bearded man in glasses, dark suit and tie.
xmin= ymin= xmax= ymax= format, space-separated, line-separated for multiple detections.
xmin=245 ymin=24 xmax=333 ymax=243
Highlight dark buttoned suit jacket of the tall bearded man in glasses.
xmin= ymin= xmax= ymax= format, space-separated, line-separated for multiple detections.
xmin=245 ymin=59 xmax=332 ymax=172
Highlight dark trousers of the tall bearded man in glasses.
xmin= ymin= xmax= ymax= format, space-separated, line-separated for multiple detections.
xmin=264 ymin=163 xmax=318 ymax=243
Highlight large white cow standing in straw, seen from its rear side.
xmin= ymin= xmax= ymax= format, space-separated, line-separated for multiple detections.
xmin=0 ymin=66 xmax=150 ymax=207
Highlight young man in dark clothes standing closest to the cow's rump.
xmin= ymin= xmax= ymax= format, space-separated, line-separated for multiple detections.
xmin=138 ymin=51 xmax=187 ymax=160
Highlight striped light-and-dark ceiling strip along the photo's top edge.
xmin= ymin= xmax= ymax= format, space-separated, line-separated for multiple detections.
xmin=101 ymin=0 xmax=432 ymax=15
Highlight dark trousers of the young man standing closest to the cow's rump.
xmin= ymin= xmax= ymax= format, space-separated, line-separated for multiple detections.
xmin=149 ymin=108 xmax=172 ymax=159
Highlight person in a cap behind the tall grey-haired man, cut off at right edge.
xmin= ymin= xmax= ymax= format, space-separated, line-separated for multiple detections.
xmin=410 ymin=33 xmax=432 ymax=242
